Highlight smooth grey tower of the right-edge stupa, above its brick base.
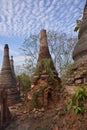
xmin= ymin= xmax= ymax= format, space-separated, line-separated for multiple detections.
xmin=73 ymin=0 xmax=87 ymax=64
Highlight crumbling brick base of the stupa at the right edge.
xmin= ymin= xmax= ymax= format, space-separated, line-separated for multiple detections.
xmin=65 ymin=61 xmax=87 ymax=94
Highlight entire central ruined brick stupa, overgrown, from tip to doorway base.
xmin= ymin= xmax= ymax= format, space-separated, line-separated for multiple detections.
xmin=31 ymin=30 xmax=61 ymax=107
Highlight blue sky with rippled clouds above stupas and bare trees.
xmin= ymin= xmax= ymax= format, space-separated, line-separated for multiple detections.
xmin=0 ymin=0 xmax=86 ymax=69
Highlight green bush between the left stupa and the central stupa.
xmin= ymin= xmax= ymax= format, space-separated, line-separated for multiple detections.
xmin=17 ymin=73 xmax=31 ymax=91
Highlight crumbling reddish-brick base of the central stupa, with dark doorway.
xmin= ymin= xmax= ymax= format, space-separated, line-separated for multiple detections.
xmin=31 ymin=59 xmax=61 ymax=108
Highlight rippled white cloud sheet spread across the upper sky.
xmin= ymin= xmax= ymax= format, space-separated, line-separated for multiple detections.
xmin=0 ymin=0 xmax=85 ymax=36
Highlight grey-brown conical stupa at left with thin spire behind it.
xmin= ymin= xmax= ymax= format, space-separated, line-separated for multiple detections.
xmin=0 ymin=44 xmax=19 ymax=105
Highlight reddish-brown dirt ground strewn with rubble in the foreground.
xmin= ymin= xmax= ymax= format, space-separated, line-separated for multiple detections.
xmin=3 ymin=97 xmax=87 ymax=130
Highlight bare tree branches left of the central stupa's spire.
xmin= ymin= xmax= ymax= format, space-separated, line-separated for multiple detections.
xmin=20 ymin=34 xmax=39 ymax=76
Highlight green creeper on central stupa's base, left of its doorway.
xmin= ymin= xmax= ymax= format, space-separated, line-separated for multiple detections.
xmin=32 ymin=84 xmax=47 ymax=107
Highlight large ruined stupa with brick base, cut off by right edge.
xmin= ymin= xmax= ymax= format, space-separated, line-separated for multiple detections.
xmin=66 ymin=0 xmax=87 ymax=88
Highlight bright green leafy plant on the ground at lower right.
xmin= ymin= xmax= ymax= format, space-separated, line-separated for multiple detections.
xmin=67 ymin=86 xmax=87 ymax=114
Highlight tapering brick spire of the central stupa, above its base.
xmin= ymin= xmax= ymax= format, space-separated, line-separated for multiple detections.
xmin=33 ymin=29 xmax=59 ymax=86
